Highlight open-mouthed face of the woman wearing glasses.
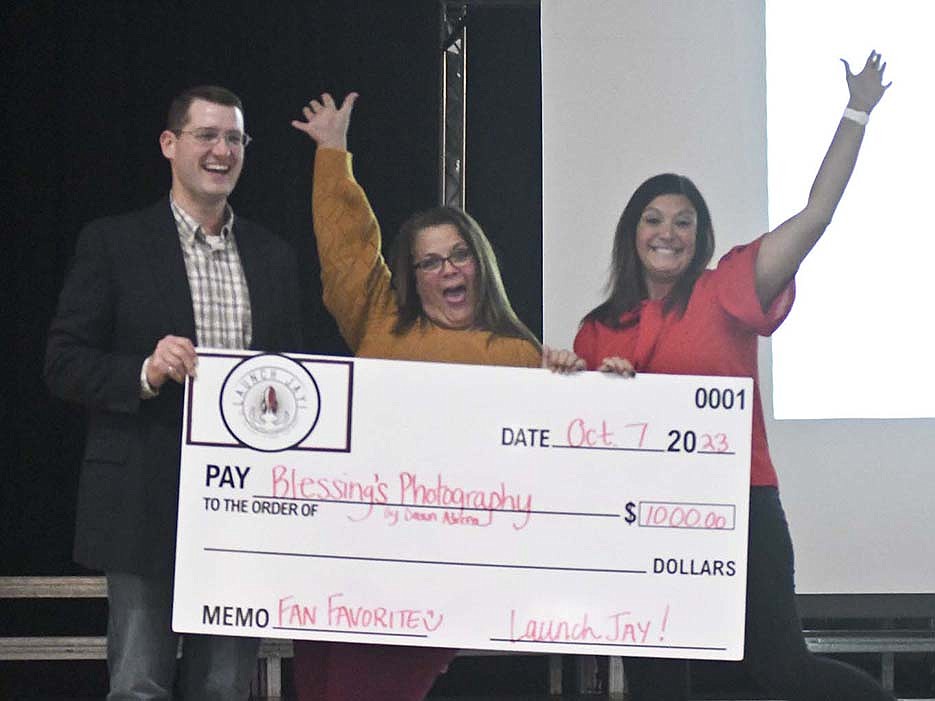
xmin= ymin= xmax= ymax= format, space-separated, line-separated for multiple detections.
xmin=412 ymin=224 xmax=477 ymax=329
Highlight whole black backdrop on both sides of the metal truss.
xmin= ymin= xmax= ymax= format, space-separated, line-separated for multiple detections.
xmin=0 ymin=0 xmax=541 ymax=575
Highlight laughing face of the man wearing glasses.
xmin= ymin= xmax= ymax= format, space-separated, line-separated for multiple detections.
xmin=159 ymin=99 xmax=244 ymax=214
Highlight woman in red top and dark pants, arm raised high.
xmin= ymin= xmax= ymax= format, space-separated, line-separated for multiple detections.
xmin=544 ymin=51 xmax=893 ymax=701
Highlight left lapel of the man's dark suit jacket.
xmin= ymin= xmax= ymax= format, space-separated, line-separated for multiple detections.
xmin=142 ymin=199 xmax=198 ymax=344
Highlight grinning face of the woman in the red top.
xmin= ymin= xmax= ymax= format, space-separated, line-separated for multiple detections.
xmin=636 ymin=194 xmax=698 ymax=299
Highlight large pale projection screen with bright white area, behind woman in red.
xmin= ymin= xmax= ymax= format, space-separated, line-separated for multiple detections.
xmin=541 ymin=0 xmax=935 ymax=594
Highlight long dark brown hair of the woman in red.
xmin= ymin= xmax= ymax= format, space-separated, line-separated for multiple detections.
xmin=583 ymin=173 xmax=714 ymax=328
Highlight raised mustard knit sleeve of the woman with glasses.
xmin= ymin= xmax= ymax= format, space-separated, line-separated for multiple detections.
xmin=312 ymin=148 xmax=397 ymax=353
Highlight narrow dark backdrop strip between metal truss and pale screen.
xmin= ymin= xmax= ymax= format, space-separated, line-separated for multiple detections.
xmin=465 ymin=6 xmax=544 ymax=338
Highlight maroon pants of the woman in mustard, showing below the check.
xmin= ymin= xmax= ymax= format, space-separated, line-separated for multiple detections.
xmin=293 ymin=640 xmax=456 ymax=701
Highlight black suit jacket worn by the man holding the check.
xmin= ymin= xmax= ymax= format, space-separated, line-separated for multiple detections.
xmin=45 ymin=199 xmax=302 ymax=574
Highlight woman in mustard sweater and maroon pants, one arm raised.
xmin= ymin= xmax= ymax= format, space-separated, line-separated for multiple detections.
xmin=292 ymin=93 xmax=541 ymax=701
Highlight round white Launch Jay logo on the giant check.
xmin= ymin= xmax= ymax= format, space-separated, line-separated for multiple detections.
xmin=220 ymin=354 xmax=321 ymax=452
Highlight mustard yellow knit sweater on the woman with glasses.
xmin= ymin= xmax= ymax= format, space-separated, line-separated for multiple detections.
xmin=312 ymin=148 xmax=540 ymax=367
